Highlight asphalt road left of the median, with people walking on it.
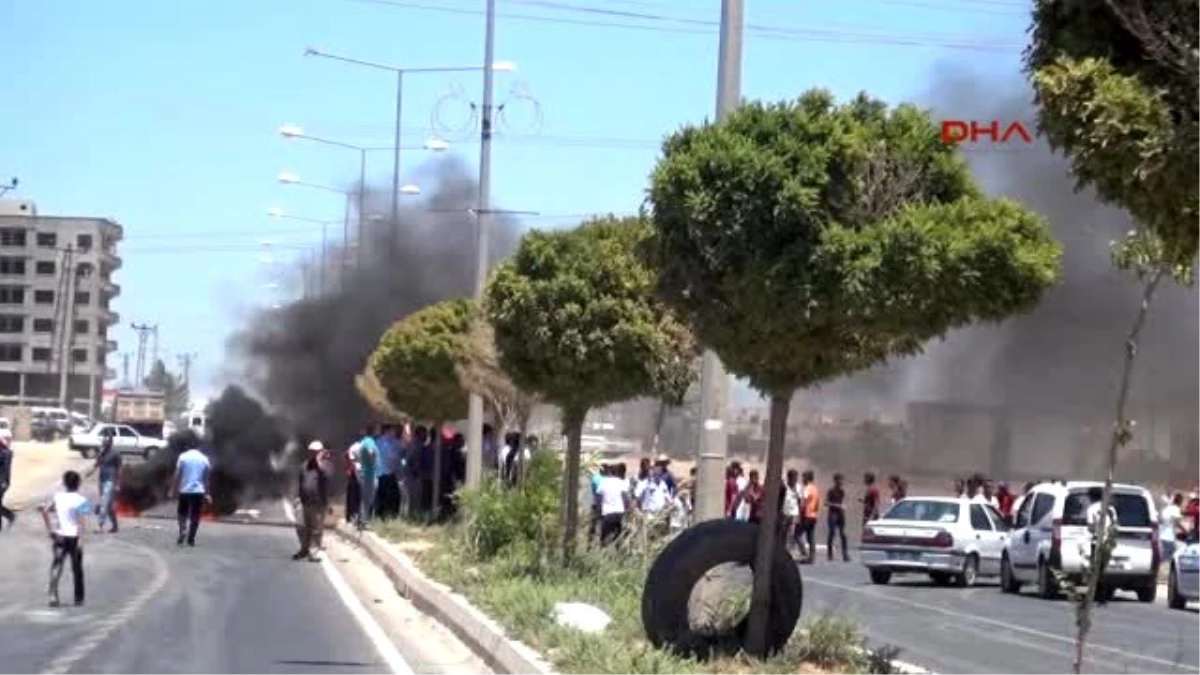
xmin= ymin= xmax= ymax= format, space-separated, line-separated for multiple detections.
xmin=0 ymin=492 xmax=490 ymax=675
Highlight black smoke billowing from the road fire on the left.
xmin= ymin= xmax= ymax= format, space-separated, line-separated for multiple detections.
xmin=225 ymin=159 xmax=518 ymax=452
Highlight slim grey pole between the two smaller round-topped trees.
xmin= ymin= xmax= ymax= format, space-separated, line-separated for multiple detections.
xmin=467 ymin=0 xmax=496 ymax=488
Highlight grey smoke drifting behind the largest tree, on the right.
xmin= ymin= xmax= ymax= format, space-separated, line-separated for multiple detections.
xmin=798 ymin=63 xmax=1200 ymax=473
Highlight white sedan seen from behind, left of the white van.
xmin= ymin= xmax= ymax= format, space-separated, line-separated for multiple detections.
xmin=859 ymin=497 xmax=1008 ymax=586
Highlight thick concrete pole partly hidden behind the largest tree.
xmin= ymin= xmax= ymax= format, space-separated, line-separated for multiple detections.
xmin=695 ymin=0 xmax=744 ymax=522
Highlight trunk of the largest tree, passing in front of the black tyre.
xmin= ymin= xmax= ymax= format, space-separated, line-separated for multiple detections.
xmin=745 ymin=394 xmax=792 ymax=658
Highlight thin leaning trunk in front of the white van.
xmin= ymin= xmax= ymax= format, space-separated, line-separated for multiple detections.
xmin=1072 ymin=268 xmax=1166 ymax=675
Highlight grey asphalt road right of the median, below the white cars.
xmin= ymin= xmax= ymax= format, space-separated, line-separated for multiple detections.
xmin=800 ymin=562 xmax=1200 ymax=675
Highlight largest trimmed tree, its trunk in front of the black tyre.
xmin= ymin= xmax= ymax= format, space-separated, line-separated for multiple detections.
xmin=649 ymin=90 xmax=1061 ymax=656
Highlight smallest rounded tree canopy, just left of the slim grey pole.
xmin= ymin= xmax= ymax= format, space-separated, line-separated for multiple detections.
xmin=368 ymin=295 xmax=474 ymax=422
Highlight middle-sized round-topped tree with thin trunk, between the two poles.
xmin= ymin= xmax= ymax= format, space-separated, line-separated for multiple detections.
xmin=487 ymin=216 xmax=688 ymax=560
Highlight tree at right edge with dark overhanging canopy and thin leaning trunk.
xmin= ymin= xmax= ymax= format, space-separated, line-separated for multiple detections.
xmin=1025 ymin=0 xmax=1200 ymax=674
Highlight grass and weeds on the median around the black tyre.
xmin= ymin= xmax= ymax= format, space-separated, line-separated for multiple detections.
xmin=377 ymin=453 xmax=894 ymax=675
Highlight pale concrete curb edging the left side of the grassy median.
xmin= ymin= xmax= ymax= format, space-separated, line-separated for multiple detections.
xmin=332 ymin=524 xmax=554 ymax=675
